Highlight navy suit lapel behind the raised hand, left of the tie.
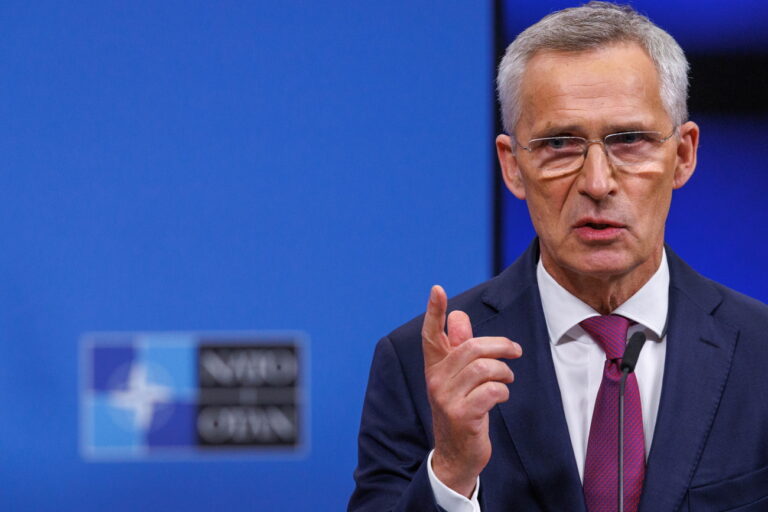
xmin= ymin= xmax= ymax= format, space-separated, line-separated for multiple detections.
xmin=483 ymin=243 xmax=586 ymax=511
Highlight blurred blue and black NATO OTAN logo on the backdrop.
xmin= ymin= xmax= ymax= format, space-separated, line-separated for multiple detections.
xmin=80 ymin=333 xmax=306 ymax=459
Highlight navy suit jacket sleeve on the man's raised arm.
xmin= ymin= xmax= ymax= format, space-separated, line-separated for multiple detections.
xmin=348 ymin=337 xmax=441 ymax=512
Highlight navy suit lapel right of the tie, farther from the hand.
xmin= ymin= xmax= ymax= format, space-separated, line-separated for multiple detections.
xmin=640 ymin=249 xmax=738 ymax=512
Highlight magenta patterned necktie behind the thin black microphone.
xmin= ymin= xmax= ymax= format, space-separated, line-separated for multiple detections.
xmin=579 ymin=315 xmax=645 ymax=512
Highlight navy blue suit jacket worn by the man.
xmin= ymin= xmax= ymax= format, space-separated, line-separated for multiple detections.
xmin=349 ymin=241 xmax=768 ymax=512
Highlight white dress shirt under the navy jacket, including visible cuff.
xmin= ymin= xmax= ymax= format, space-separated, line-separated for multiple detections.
xmin=427 ymin=251 xmax=669 ymax=512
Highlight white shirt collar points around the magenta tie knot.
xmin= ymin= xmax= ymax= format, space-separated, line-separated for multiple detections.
xmin=536 ymin=250 xmax=669 ymax=344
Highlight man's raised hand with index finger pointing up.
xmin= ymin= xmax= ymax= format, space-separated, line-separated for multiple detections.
xmin=421 ymin=286 xmax=522 ymax=497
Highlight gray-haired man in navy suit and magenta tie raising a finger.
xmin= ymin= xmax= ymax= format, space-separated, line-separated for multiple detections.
xmin=349 ymin=2 xmax=768 ymax=512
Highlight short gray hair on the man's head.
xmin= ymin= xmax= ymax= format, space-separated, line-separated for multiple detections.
xmin=496 ymin=2 xmax=688 ymax=135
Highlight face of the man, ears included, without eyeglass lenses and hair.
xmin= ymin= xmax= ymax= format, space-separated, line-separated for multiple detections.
xmin=497 ymin=44 xmax=698 ymax=284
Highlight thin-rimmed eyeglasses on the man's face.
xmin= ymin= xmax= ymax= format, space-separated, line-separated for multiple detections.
xmin=517 ymin=127 xmax=677 ymax=175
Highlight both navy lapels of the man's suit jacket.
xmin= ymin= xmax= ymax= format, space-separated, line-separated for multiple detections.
xmin=474 ymin=239 xmax=738 ymax=512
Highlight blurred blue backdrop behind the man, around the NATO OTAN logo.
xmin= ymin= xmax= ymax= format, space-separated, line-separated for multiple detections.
xmin=0 ymin=0 xmax=768 ymax=512
